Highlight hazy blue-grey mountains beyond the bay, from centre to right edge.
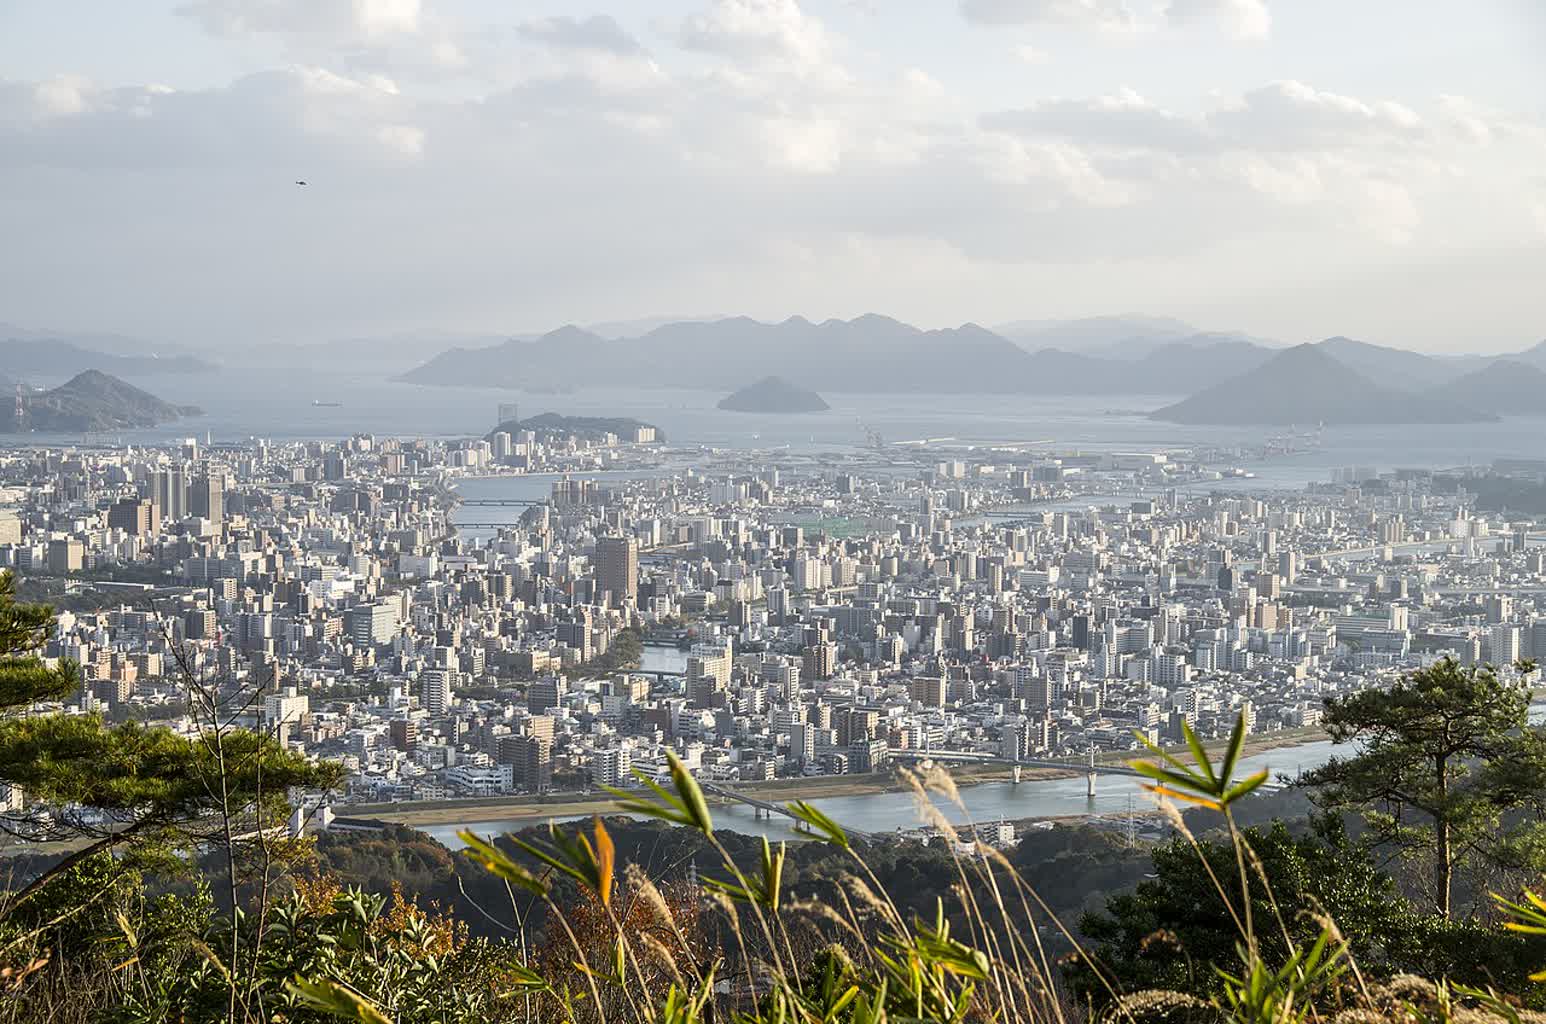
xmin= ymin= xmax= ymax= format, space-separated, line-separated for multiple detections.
xmin=400 ymin=314 xmax=1546 ymax=422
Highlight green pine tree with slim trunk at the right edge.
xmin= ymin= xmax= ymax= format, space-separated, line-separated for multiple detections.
xmin=1300 ymin=657 xmax=1546 ymax=919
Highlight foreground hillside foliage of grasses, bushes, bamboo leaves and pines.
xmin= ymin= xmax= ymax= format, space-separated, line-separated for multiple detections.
xmin=0 ymin=586 xmax=1546 ymax=1024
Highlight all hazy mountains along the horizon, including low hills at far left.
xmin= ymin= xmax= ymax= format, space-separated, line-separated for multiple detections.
xmin=0 ymin=314 xmax=1546 ymax=424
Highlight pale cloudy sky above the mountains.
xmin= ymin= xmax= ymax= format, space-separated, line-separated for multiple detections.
xmin=0 ymin=0 xmax=1546 ymax=353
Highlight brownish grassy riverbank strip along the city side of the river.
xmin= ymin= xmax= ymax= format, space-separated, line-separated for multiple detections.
xmin=354 ymin=729 xmax=1326 ymax=828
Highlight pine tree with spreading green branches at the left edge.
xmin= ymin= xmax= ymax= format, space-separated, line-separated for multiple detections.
xmin=0 ymin=572 xmax=340 ymax=914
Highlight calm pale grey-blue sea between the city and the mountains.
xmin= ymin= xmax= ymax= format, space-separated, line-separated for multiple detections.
xmin=18 ymin=370 xmax=1546 ymax=493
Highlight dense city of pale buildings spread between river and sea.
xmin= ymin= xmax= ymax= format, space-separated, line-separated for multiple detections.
xmin=0 ymin=410 xmax=1546 ymax=838
